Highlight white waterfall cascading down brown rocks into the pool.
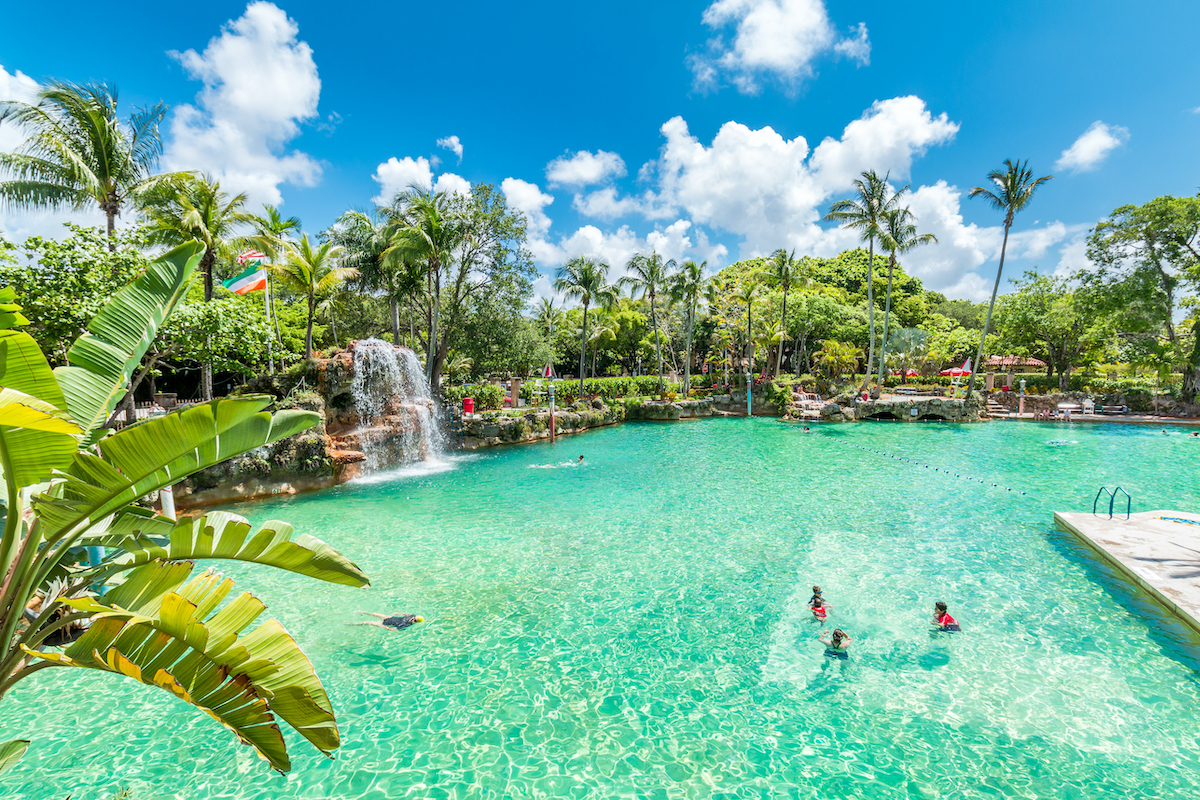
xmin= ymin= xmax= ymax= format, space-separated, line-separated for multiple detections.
xmin=350 ymin=339 xmax=446 ymax=473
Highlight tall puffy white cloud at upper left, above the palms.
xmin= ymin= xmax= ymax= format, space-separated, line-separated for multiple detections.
xmin=163 ymin=0 xmax=322 ymax=204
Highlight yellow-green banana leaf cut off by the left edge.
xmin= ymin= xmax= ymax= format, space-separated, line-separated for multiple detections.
xmin=0 ymin=330 xmax=80 ymax=486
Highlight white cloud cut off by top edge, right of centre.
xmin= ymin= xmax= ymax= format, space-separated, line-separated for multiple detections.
xmin=689 ymin=0 xmax=871 ymax=94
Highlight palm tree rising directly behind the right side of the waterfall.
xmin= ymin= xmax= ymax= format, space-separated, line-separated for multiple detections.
xmin=383 ymin=188 xmax=462 ymax=386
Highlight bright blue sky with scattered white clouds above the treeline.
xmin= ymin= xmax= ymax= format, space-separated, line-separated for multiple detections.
xmin=0 ymin=0 xmax=1200 ymax=299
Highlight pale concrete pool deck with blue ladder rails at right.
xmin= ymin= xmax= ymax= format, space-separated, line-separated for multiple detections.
xmin=1054 ymin=511 xmax=1200 ymax=633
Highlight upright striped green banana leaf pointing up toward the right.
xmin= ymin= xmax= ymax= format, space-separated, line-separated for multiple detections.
xmin=54 ymin=241 xmax=204 ymax=444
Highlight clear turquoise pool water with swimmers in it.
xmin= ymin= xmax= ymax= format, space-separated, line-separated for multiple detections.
xmin=7 ymin=419 xmax=1200 ymax=800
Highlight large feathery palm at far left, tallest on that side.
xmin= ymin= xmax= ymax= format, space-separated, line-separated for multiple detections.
xmin=0 ymin=82 xmax=188 ymax=251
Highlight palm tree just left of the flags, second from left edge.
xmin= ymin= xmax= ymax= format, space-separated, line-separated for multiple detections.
xmin=144 ymin=175 xmax=251 ymax=401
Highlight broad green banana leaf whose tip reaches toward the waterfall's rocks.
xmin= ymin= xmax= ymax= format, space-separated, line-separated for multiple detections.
xmin=34 ymin=395 xmax=320 ymax=585
